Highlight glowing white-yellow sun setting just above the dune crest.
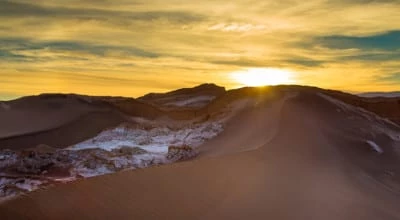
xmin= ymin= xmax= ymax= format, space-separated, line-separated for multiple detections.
xmin=230 ymin=68 xmax=293 ymax=86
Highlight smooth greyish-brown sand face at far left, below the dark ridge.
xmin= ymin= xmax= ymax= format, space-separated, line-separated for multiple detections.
xmin=0 ymin=95 xmax=96 ymax=138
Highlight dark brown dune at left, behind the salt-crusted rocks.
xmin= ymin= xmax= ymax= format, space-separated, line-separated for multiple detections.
xmin=0 ymin=94 xmax=169 ymax=149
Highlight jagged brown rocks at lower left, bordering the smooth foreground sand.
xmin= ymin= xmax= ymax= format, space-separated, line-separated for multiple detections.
xmin=0 ymin=145 xmax=167 ymax=199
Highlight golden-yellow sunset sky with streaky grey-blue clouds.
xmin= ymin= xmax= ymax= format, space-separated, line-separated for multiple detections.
xmin=0 ymin=0 xmax=400 ymax=100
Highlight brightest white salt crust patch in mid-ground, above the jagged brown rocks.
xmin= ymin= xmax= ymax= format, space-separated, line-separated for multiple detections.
xmin=69 ymin=122 xmax=223 ymax=153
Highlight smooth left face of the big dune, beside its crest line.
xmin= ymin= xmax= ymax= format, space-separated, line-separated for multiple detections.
xmin=200 ymin=93 xmax=296 ymax=157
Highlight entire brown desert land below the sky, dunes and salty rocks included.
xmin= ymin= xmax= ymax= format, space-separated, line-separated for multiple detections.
xmin=0 ymin=84 xmax=400 ymax=219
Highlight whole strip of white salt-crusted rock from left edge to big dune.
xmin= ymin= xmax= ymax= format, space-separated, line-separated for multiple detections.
xmin=0 ymin=119 xmax=223 ymax=202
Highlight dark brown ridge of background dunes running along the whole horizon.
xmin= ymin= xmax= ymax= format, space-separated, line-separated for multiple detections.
xmin=0 ymin=84 xmax=400 ymax=149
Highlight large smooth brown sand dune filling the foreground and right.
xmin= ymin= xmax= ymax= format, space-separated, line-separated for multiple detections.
xmin=0 ymin=90 xmax=400 ymax=219
